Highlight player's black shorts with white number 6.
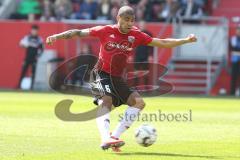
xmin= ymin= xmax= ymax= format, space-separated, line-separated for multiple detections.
xmin=90 ymin=69 xmax=133 ymax=107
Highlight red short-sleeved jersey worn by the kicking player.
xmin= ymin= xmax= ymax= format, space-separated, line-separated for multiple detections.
xmin=90 ymin=24 xmax=153 ymax=76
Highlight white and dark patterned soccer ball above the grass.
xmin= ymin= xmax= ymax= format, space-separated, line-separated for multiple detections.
xmin=135 ymin=124 xmax=157 ymax=147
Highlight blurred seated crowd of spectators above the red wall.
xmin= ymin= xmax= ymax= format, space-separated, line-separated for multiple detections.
xmin=9 ymin=0 xmax=218 ymax=22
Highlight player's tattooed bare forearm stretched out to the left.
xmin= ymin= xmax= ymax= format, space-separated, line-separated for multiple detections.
xmin=46 ymin=29 xmax=89 ymax=45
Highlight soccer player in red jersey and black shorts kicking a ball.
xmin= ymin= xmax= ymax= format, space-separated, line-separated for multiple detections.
xmin=46 ymin=6 xmax=197 ymax=151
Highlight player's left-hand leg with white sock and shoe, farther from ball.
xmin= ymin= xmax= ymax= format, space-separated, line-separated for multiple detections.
xmin=96 ymin=95 xmax=125 ymax=151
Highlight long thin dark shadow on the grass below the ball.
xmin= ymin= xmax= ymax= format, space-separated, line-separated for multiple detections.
xmin=114 ymin=152 xmax=223 ymax=159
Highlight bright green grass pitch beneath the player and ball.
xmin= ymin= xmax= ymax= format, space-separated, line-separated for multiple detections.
xmin=0 ymin=92 xmax=240 ymax=160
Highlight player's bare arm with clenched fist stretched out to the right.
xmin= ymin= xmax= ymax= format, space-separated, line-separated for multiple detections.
xmin=148 ymin=34 xmax=197 ymax=48
